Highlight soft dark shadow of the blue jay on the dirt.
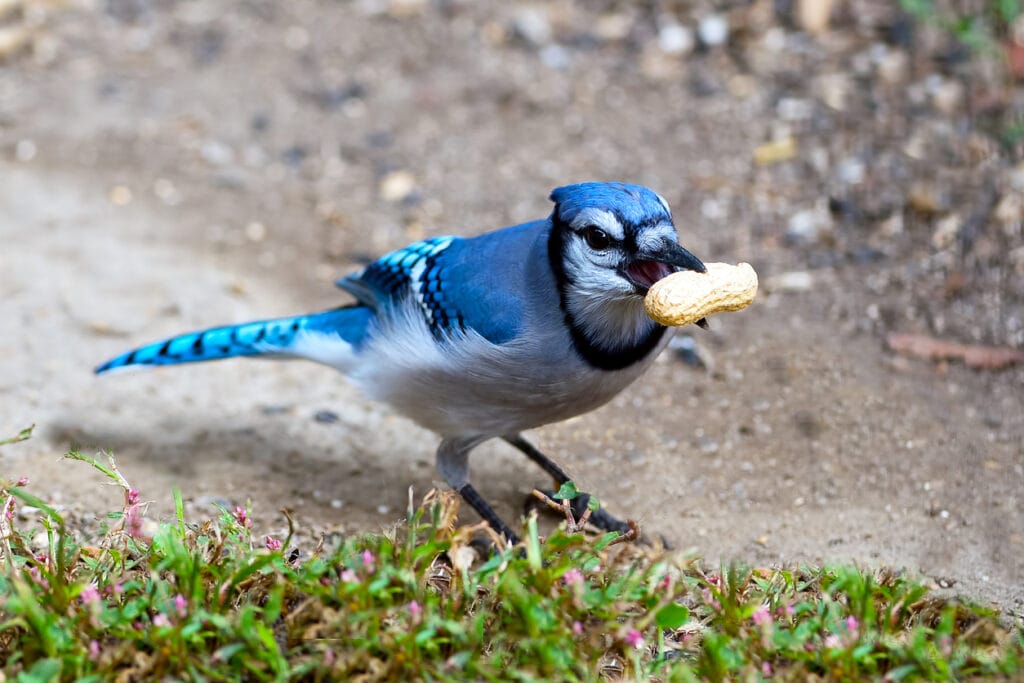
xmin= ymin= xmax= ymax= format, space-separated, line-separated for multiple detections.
xmin=42 ymin=417 xmax=528 ymax=523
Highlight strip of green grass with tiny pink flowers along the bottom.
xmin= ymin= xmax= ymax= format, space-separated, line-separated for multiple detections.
xmin=0 ymin=440 xmax=1024 ymax=681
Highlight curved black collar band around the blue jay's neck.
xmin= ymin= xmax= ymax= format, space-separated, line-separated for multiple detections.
xmin=548 ymin=218 xmax=666 ymax=371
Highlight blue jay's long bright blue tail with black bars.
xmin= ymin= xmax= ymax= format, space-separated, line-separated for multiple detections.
xmin=95 ymin=306 xmax=374 ymax=375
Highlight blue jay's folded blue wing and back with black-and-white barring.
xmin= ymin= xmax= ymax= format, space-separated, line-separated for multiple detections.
xmin=337 ymin=221 xmax=546 ymax=344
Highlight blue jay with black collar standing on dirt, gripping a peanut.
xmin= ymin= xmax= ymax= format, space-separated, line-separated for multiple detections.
xmin=96 ymin=182 xmax=705 ymax=542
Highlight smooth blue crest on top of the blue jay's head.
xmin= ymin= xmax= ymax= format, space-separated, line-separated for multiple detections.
xmin=551 ymin=182 xmax=672 ymax=225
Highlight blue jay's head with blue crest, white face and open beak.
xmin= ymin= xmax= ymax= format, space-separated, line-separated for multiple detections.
xmin=551 ymin=182 xmax=705 ymax=299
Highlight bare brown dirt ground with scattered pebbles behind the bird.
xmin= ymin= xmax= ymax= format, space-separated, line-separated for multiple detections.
xmin=0 ymin=0 xmax=1024 ymax=614
